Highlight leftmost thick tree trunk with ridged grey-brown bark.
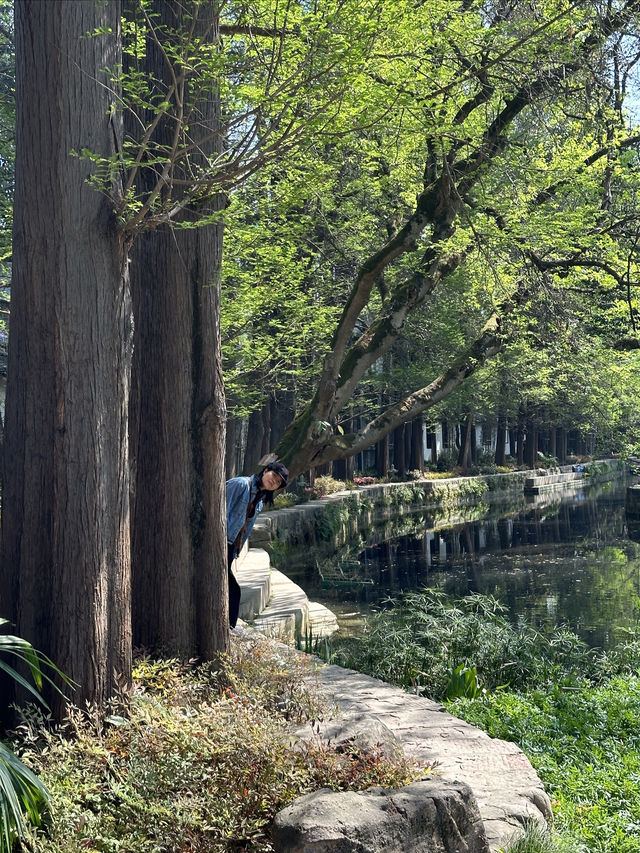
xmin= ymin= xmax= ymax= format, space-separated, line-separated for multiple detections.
xmin=0 ymin=0 xmax=132 ymax=717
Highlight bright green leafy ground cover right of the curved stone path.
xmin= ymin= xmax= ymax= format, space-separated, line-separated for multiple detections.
xmin=448 ymin=675 xmax=640 ymax=853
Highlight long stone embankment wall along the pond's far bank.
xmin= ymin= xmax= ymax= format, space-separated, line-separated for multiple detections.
xmin=251 ymin=459 xmax=623 ymax=552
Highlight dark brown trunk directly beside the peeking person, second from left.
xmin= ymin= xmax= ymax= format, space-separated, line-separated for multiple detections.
xmin=126 ymin=0 xmax=229 ymax=658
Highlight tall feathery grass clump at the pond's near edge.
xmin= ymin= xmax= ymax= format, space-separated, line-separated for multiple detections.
xmin=331 ymin=590 xmax=611 ymax=699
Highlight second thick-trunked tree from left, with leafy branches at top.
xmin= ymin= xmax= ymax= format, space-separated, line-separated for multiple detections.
xmin=115 ymin=0 xmax=376 ymax=657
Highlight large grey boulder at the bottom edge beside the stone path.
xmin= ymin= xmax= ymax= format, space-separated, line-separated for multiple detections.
xmin=272 ymin=778 xmax=489 ymax=853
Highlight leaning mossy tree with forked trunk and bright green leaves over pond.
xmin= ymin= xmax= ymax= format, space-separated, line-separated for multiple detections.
xmin=276 ymin=0 xmax=640 ymax=480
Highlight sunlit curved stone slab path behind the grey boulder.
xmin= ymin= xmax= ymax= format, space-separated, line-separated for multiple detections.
xmin=308 ymin=664 xmax=551 ymax=850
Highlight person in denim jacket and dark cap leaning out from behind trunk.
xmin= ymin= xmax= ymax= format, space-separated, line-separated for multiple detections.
xmin=226 ymin=462 xmax=289 ymax=628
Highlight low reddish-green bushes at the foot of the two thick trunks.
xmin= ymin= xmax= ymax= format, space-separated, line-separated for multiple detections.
xmin=19 ymin=639 xmax=413 ymax=853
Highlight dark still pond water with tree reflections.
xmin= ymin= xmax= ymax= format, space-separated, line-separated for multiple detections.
xmin=298 ymin=482 xmax=640 ymax=648
